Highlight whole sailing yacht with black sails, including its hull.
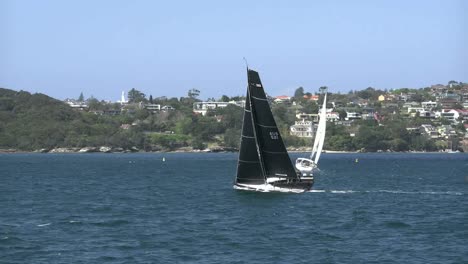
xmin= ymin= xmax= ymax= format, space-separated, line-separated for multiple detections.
xmin=234 ymin=68 xmax=314 ymax=193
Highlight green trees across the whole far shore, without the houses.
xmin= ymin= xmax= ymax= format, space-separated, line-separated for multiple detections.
xmin=0 ymin=84 xmax=464 ymax=152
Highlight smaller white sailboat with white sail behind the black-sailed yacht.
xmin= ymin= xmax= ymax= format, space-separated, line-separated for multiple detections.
xmin=296 ymin=89 xmax=327 ymax=176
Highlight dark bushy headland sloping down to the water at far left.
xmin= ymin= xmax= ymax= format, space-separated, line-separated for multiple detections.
xmin=0 ymin=88 xmax=126 ymax=150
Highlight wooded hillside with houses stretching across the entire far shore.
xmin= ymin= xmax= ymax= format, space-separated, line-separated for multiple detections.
xmin=0 ymin=83 xmax=468 ymax=152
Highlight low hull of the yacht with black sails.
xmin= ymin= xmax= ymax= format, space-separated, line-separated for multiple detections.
xmin=234 ymin=177 xmax=314 ymax=193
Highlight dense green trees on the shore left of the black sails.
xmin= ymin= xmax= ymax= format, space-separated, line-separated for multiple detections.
xmin=0 ymin=88 xmax=242 ymax=151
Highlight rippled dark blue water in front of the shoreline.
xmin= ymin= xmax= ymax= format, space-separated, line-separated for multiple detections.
xmin=0 ymin=153 xmax=468 ymax=263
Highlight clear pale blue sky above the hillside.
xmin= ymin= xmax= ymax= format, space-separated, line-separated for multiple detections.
xmin=0 ymin=0 xmax=468 ymax=101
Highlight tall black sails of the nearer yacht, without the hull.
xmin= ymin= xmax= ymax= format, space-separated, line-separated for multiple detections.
xmin=236 ymin=70 xmax=297 ymax=184
